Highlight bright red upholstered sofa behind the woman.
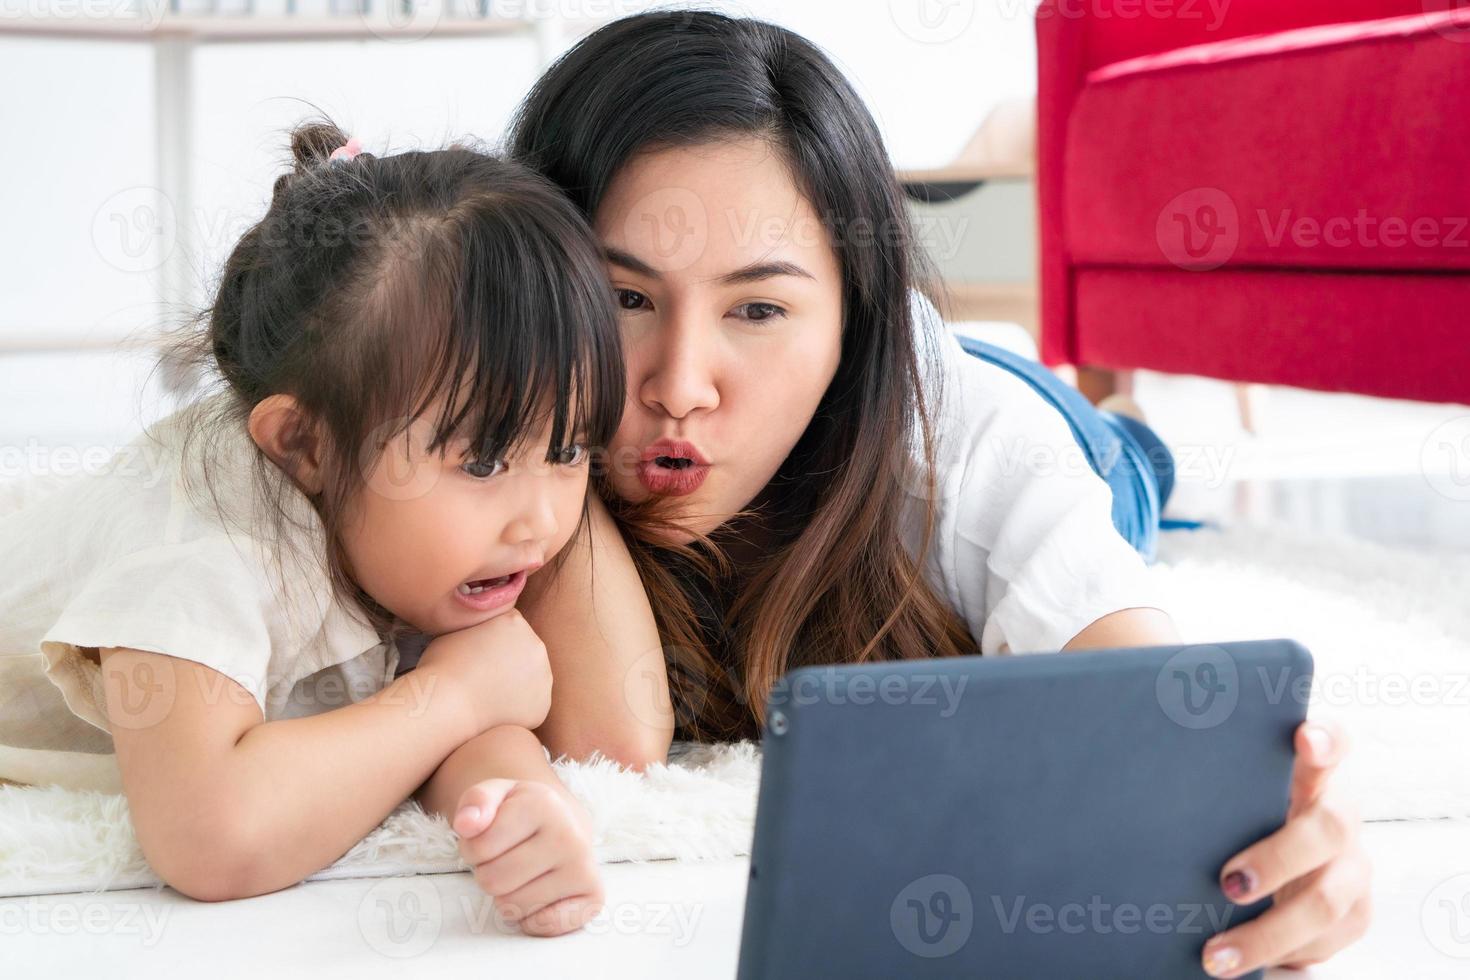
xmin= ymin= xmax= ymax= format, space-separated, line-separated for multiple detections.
xmin=1036 ymin=0 xmax=1470 ymax=403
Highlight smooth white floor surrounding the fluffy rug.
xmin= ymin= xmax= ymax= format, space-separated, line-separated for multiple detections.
xmin=0 ymin=345 xmax=1470 ymax=980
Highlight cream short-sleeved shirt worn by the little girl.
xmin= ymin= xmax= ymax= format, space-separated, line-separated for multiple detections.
xmin=0 ymin=395 xmax=398 ymax=792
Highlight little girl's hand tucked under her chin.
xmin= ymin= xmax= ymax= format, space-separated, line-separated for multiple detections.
xmin=415 ymin=608 xmax=551 ymax=733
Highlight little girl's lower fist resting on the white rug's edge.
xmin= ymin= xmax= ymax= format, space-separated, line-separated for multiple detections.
xmin=451 ymin=779 xmax=603 ymax=936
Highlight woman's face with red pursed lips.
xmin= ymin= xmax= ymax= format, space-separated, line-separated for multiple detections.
xmin=594 ymin=138 xmax=842 ymax=539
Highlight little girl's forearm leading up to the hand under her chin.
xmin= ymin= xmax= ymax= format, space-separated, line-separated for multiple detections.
xmin=228 ymin=667 xmax=475 ymax=898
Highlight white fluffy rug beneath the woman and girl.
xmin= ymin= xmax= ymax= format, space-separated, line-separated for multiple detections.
xmin=0 ymin=527 xmax=1470 ymax=896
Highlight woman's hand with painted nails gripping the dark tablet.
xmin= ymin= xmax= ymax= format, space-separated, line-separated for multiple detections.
xmin=1204 ymin=721 xmax=1372 ymax=977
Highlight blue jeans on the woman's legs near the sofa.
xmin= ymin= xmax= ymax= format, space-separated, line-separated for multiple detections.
xmin=958 ymin=336 xmax=1175 ymax=563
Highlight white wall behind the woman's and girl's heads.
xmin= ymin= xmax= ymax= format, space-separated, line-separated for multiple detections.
xmin=0 ymin=0 xmax=1035 ymax=347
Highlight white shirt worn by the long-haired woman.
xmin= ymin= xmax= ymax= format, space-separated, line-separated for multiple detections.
xmin=901 ymin=292 xmax=1161 ymax=654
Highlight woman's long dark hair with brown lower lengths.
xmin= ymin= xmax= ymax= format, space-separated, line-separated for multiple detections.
xmin=509 ymin=10 xmax=975 ymax=738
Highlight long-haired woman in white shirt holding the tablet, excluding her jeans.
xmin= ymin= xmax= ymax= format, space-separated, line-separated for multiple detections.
xmin=482 ymin=12 xmax=1369 ymax=976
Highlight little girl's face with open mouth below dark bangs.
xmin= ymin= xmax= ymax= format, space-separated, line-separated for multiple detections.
xmin=343 ymin=406 xmax=588 ymax=636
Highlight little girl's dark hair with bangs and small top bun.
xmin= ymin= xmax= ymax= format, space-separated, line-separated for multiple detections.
xmin=162 ymin=120 xmax=625 ymax=636
